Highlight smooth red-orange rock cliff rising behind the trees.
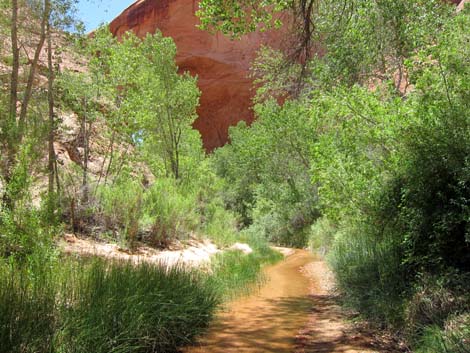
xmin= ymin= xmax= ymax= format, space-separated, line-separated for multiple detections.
xmin=110 ymin=0 xmax=281 ymax=151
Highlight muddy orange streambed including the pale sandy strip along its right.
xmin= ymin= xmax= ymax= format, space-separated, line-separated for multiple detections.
xmin=184 ymin=250 xmax=382 ymax=353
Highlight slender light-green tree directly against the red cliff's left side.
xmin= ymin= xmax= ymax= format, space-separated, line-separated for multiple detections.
xmin=134 ymin=33 xmax=200 ymax=179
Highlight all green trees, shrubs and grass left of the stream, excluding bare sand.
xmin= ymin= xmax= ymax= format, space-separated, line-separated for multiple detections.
xmin=0 ymin=1 xmax=281 ymax=353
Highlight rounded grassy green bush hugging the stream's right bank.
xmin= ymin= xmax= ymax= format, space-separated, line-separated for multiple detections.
xmin=328 ymin=224 xmax=407 ymax=327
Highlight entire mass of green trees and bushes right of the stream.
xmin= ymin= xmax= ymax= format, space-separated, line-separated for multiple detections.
xmin=200 ymin=0 xmax=470 ymax=352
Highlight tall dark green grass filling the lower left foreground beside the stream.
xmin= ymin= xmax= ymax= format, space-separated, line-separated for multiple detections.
xmin=0 ymin=259 xmax=219 ymax=353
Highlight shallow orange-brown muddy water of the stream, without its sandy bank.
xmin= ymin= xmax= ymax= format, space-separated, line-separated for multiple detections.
xmin=185 ymin=250 xmax=313 ymax=353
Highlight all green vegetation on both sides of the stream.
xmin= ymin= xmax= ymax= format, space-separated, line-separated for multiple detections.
xmin=0 ymin=0 xmax=470 ymax=353
